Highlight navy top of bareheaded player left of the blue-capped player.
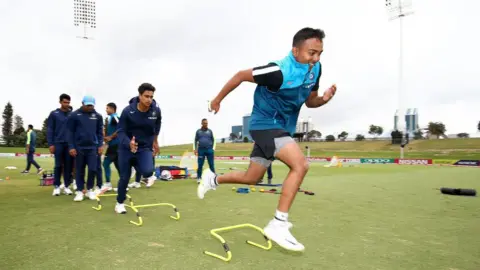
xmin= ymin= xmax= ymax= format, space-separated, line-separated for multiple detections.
xmin=47 ymin=109 xmax=71 ymax=146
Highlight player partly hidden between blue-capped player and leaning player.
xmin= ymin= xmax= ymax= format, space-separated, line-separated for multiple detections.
xmin=102 ymin=102 xmax=120 ymax=191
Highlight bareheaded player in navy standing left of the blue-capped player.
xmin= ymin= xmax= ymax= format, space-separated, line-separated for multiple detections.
xmin=47 ymin=94 xmax=73 ymax=196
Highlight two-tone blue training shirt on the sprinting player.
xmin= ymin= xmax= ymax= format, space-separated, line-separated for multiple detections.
xmin=250 ymin=52 xmax=322 ymax=135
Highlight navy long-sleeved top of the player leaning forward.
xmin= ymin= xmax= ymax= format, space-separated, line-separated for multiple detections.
xmin=117 ymin=97 xmax=162 ymax=152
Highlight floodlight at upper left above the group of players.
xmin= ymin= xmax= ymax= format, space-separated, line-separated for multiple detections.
xmin=73 ymin=0 xmax=97 ymax=100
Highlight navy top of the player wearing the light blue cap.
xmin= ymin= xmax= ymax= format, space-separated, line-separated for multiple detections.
xmin=67 ymin=108 xmax=103 ymax=150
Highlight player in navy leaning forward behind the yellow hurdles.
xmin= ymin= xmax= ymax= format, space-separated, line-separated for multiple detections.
xmin=115 ymin=83 xmax=162 ymax=214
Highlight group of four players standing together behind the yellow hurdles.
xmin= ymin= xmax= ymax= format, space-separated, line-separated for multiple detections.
xmin=47 ymin=83 xmax=161 ymax=207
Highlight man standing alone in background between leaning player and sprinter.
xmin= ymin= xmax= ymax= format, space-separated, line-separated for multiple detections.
xmin=193 ymin=118 xmax=217 ymax=183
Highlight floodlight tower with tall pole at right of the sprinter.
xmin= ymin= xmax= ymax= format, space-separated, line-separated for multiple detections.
xmin=385 ymin=0 xmax=414 ymax=158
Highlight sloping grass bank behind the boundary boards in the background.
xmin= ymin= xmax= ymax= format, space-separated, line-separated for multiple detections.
xmin=0 ymin=138 xmax=480 ymax=160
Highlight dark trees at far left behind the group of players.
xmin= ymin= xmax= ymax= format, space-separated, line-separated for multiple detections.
xmin=2 ymin=102 xmax=48 ymax=147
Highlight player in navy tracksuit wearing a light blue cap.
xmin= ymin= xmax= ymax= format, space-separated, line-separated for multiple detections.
xmin=67 ymin=96 xmax=103 ymax=201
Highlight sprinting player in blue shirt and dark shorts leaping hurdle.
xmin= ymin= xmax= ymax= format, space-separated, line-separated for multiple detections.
xmin=197 ymin=28 xmax=336 ymax=251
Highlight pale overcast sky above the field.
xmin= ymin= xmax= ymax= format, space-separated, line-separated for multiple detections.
xmin=0 ymin=0 xmax=480 ymax=145
